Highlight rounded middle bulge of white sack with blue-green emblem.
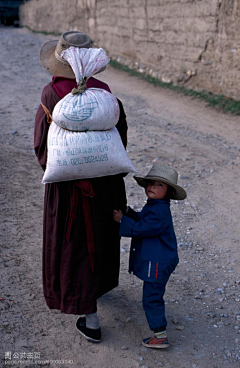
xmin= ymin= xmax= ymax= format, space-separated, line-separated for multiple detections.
xmin=52 ymin=88 xmax=120 ymax=132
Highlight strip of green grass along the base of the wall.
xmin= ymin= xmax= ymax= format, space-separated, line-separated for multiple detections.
xmin=110 ymin=60 xmax=240 ymax=115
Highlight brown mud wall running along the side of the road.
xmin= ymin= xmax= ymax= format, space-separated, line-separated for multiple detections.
xmin=20 ymin=0 xmax=240 ymax=100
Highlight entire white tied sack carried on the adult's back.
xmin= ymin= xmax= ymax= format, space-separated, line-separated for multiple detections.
xmin=42 ymin=47 xmax=136 ymax=183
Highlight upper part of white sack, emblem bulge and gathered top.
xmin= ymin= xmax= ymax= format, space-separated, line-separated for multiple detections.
xmin=52 ymin=47 xmax=120 ymax=132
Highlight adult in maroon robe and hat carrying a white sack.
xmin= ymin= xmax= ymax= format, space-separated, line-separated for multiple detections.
xmin=34 ymin=31 xmax=127 ymax=342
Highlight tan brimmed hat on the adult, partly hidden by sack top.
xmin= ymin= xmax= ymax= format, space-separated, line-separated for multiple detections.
xmin=40 ymin=31 xmax=92 ymax=78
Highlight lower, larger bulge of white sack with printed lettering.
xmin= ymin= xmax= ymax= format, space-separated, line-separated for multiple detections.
xmin=42 ymin=121 xmax=136 ymax=184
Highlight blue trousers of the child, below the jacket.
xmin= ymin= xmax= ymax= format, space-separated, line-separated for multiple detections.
xmin=143 ymin=281 xmax=167 ymax=331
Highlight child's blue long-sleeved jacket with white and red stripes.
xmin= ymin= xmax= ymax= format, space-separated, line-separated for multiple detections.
xmin=119 ymin=199 xmax=179 ymax=283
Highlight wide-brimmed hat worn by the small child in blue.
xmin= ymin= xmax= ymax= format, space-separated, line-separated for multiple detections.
xmin=134 ymin=163 xmax=187 ymax=199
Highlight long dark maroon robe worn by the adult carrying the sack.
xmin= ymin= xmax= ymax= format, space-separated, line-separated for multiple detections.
xmin=34 ymin=77 xmax=127 ymax=314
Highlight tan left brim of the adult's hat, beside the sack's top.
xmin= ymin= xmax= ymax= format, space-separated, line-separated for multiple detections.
xmin=40 ymin=40 xmax=75 ymax=78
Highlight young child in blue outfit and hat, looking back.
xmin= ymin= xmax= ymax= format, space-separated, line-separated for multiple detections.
xmin=113 ymin=163 xmax=187 ymax=348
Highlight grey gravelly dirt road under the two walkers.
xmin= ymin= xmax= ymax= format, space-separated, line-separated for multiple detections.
xmin=0 ymin=27 xmax=240 ymax=368
